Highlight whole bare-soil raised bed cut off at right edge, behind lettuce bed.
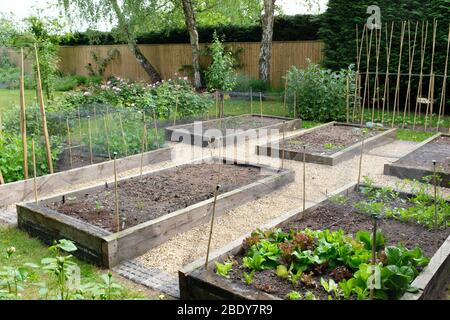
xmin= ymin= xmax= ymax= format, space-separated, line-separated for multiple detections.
xmin=384 ymin=133 xmax=450 ymax=188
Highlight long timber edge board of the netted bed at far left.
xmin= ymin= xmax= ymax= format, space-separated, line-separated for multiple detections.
xmin=0 ymin=147 xmax=172 ymax=206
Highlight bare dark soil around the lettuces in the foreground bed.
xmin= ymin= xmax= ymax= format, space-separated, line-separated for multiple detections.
xmin=223 ymin=193 xmax=450 ymax=299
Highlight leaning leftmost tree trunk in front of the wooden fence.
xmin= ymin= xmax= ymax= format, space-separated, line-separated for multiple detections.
xmin=109 ymin=0 xmax=161 ymax=82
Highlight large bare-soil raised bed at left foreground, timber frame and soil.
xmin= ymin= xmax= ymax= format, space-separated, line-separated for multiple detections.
xmin=17 ymin=158 xmax=294 ymax=267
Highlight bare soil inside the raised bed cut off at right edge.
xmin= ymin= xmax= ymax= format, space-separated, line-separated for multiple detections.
xmin=395 ymin=136 xmax=450 ymax=173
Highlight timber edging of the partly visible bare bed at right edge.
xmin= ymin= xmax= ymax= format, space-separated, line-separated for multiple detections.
xmin=384 ymin=133 xmax=450 ymax=188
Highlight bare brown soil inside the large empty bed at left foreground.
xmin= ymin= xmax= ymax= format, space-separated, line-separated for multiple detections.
xmin=45 ymin=163 xmax=264 ymax=232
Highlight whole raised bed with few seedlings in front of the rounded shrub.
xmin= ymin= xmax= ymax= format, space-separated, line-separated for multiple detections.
xmin=256 ymin=122 xmax=396 ymax=166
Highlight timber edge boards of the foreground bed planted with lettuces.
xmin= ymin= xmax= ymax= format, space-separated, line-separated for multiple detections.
xmin=178 ymin=183 xmax=450 ymax=300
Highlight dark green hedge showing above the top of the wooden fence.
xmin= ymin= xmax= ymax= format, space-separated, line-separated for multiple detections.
xmin=61 ymin=15 xmax=320 ymax=46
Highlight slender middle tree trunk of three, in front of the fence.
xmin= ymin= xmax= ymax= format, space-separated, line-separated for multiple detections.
xmin=182 ymin=0 xmax=202 ymax=89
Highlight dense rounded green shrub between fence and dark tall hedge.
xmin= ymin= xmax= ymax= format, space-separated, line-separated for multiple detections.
xmin=287 ymin=63 xmax=355 ymax=122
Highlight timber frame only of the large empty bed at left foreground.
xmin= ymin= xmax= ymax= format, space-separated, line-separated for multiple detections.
xmin=17 ymin=158 xmax=294 ymax=267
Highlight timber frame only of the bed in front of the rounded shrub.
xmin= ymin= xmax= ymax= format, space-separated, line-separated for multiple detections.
xmin=256 ymin=122 xmax=397 ymax=166
